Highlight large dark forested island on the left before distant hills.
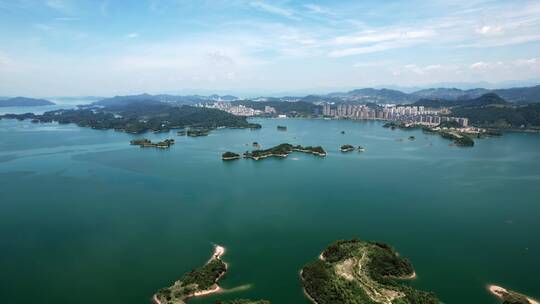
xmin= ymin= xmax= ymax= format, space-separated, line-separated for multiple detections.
xmin=2 ymin=101 xmax=261 ymax=134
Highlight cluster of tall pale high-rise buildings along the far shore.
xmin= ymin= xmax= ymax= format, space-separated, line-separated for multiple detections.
xmin=323 ymin=103 xmax=469 ymax=127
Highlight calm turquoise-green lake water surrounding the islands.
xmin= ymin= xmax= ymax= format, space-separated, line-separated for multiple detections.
xmin=0 ymin=119 xmax=540 ymax=304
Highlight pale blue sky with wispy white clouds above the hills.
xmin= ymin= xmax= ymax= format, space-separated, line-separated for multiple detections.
xmin=0 ymin=0 xmax=540 ymax=96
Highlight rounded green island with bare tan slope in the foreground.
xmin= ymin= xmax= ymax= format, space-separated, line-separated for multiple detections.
xmin=300 ymin=239 xmax=439 ymax=304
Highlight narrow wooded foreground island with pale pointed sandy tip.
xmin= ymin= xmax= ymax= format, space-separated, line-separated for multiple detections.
xmin=153 ymin=245 xmax=227 ymax=304
